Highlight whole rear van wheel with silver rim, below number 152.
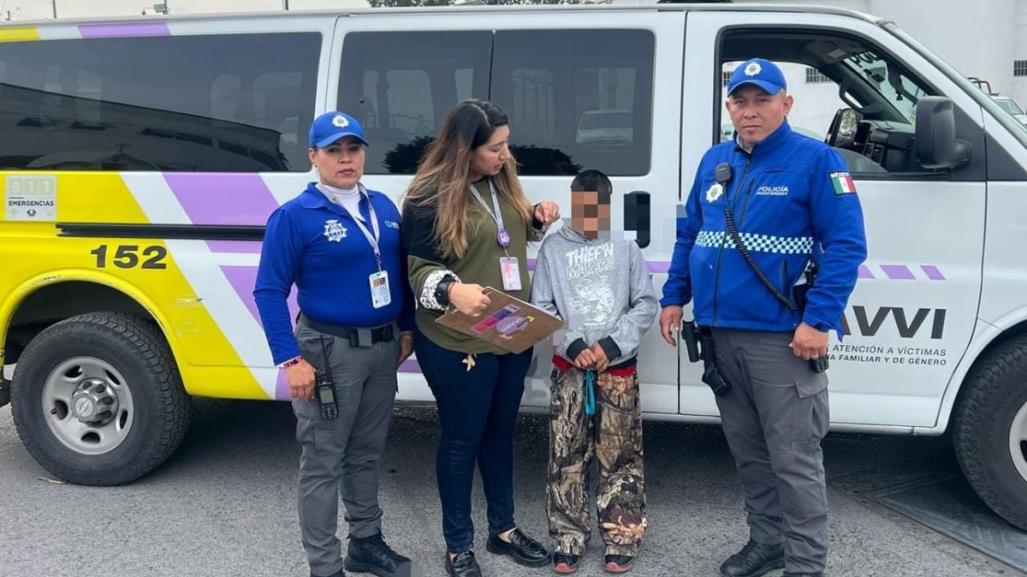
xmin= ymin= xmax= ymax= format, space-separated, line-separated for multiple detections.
xmin=11 ymin=312 xmax=190 ymax=485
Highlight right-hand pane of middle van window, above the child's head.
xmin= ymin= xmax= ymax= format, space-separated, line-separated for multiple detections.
xmin=491 ymin=30 xmax=655 ymax=176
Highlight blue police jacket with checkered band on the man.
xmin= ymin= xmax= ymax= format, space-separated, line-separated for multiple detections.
xmin=660 ymin=121 xmax=867 ymax=337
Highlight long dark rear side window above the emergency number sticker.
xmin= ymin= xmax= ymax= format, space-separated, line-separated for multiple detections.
xmin=0 ymin=33 xmax=321 ymax=172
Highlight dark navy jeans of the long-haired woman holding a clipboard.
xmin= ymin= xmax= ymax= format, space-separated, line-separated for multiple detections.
xmin=414 ymin=333 xmax=531 ymax=552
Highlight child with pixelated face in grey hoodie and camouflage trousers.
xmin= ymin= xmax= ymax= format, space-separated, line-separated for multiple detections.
xmin=531 ymin=166 xmax=657 ymax=574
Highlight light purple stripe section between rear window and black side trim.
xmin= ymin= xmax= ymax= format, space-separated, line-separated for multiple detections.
xmin=164 ymin=172 xmax=278 ymax=226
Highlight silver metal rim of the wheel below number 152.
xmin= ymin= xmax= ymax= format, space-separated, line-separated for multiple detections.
xmin=41 ymin=356 xmax=136 ymax=455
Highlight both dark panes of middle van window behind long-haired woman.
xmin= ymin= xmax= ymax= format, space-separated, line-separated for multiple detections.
xmin=339 ymin=30 xmax=655 ymax=176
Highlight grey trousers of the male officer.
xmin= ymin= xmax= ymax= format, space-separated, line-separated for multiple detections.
xmin=712 ymin=329 xmax=830 ymax=573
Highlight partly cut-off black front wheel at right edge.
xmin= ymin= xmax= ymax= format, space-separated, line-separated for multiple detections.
xmin=953 ymin=337 xmax=1027 ymax=530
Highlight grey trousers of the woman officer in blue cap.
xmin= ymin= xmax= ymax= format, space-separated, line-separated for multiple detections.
xmin=293 ymin=324 xmax=400 ymax=575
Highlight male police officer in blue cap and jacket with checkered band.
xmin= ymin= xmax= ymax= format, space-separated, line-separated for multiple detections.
xmin=660 ymin=59 xmax=867 ymax=577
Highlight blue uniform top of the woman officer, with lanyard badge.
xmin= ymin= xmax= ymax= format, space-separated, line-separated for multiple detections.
xmin=254 ymin=183 xmax=414 ymax=364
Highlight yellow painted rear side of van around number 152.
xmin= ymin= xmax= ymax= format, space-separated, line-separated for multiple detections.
xmin=0 ymin=172 xmax=269 ymax=398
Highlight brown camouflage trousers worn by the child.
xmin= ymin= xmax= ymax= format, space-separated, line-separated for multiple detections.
xmin=545 ymin=369 xmax=646 ymax=556
